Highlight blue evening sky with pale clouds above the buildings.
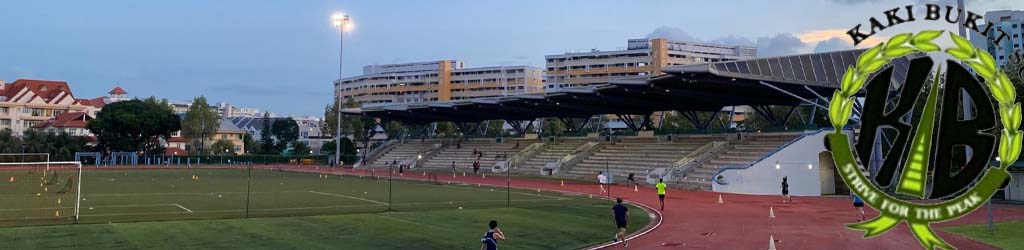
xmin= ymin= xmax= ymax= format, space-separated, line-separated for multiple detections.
xmin=0 ymin=0 xmax=1024 ymax=116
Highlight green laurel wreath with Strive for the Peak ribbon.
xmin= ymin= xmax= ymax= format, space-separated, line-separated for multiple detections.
xmin=828 ymin=31 xmax=1024 ymax=249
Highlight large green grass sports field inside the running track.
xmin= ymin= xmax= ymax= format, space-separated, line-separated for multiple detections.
xmin=0 ymin=169 xmax=649 ymax=249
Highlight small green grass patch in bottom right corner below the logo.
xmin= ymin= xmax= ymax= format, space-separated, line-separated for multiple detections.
xmin=939 ymin=221 xmax=1024 ymax=249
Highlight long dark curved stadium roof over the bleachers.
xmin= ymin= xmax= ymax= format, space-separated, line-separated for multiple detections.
xmin=342 ymin=49 xmax=908 ymax=123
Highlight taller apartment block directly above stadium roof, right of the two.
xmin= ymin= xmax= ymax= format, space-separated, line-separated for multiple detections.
xmin=545 ymin=38 xmax=757 ymax=89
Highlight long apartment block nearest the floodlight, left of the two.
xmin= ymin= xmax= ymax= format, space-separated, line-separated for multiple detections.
xmin=334 ymin=60 xmax=544 ymax=106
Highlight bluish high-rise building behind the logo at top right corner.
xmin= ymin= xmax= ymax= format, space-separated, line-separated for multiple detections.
xmin=970 ymin=10 xmax=1024 ymax=66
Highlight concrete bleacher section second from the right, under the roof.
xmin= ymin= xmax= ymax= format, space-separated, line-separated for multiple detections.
xmin=566 ymin=137 xmax=711 ymax=182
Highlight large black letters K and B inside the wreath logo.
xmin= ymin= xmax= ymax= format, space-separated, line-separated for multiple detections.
xmin=856 ymin=57 xmax=995 ymax=199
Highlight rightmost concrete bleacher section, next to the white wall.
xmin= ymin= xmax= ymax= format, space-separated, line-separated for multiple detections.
xmin=673 ymin=132 xmax=801 ymax=191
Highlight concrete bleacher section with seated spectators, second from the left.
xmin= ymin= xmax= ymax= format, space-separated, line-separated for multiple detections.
xmin=423 ymin=139 xmax=534 ymax=172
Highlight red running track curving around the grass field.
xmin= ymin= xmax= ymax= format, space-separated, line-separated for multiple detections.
xmin=81 ymin=166 xmax=1024 ymax=250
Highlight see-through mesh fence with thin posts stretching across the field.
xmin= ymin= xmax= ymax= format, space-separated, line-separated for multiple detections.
xmin=0 ymin=160 xmax=605 ymax=226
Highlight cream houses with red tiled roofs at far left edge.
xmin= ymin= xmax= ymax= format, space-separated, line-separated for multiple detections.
xmin=0 ymin=79 xmax=127 ymax=134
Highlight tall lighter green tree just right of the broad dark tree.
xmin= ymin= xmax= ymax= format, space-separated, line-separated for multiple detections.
xmin=181 ymin=95 xmax=220 ymax=155
